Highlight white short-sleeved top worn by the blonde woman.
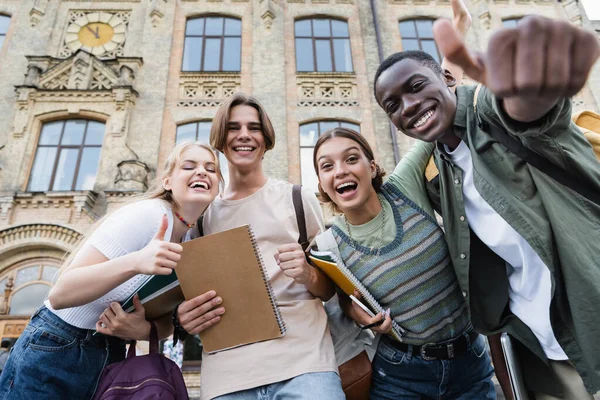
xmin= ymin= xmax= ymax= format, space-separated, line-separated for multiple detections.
xmin=44 ymin=199 xmax=173 ymax=329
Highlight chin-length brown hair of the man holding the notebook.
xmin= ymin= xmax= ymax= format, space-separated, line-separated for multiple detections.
xmin=210 ymin=93 xmax=275 ymax=152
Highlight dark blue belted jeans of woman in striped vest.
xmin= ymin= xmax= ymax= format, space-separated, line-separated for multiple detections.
xmin=371 ymin=334 xmax=496 ymax=400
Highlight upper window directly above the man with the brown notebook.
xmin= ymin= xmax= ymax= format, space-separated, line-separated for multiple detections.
xmin=181 ymin=16 xmax=242 ymax=72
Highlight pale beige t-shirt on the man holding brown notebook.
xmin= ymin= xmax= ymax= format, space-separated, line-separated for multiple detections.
xmin=200 ymin=179 xmax=337 ymax=400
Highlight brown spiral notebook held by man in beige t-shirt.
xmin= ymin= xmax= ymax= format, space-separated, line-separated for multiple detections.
xmin=175 ymin=225 xmax=285 ymax=353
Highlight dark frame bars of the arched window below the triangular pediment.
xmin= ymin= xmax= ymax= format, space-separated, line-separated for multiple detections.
xmin=27 ymin=118 xmax=106 ymax=192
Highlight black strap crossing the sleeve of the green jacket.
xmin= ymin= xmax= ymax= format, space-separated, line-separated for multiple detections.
xmin=479 ymin=120 xmax=600 ymax=205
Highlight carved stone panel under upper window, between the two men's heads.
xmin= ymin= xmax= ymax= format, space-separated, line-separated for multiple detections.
xmin=296 ymin=72 xmax=358 ymax=107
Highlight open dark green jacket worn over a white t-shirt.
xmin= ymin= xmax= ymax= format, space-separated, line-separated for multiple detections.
xmin=435 ymin=86 xmax=600 ymax=394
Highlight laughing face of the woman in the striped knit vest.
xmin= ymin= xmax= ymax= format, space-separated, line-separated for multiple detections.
xmin=315 ymin=137 xmax=378 ymax=215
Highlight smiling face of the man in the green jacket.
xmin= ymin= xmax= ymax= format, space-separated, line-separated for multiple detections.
xmin=375 ymin=58 xmax=456 ymax=142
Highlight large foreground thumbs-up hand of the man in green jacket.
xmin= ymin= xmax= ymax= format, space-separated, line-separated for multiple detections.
xmin=433 ymin=16 xmax=600 ymax=122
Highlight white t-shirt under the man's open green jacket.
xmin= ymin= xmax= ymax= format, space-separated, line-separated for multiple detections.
xmin=446 ymin=141 xmax=568 ymax=360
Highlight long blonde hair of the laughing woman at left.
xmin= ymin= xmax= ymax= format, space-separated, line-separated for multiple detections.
xmin=58 ymin=140 xmax=224 ymax=275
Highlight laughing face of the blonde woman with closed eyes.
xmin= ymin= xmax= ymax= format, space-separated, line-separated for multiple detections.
xmin=163 ymin=146 xmax=219 ymax=208
